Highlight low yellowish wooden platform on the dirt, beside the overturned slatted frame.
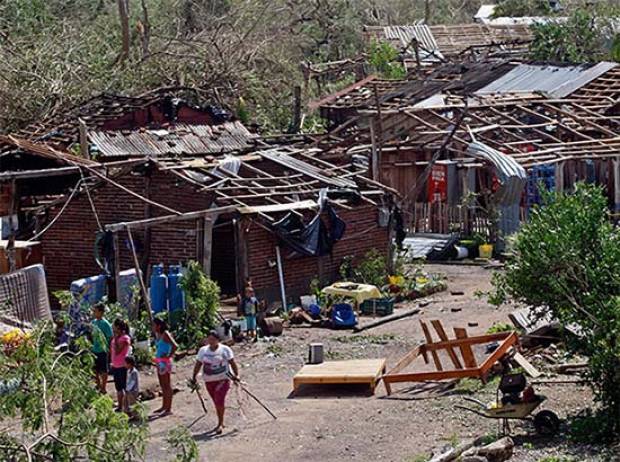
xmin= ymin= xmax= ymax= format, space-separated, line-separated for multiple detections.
xmin=293 ymin=358 xmax=386 ymax=393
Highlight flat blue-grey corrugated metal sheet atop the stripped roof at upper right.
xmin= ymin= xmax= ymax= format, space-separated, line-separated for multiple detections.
xmin=476 ymin=62 xmax=617 ymax=98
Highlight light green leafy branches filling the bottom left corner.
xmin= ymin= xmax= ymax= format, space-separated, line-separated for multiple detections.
xmin=0 ymin=323 xmax=147 ymax=462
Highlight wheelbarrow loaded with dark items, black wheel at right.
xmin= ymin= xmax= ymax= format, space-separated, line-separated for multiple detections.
xmin=455 ymin=374 xmax=560 ymax=436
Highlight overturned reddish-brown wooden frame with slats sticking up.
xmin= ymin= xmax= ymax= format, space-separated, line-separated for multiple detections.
xmin=383 ymin=320 xmax=518 ymax=395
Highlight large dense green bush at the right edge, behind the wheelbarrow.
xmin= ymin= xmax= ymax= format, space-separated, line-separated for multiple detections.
xmin=493 ymin=184 xmax=620 ymax=436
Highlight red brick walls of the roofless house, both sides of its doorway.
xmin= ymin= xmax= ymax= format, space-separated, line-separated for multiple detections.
xmin=41 ymin=166 xmax=388 ymax=301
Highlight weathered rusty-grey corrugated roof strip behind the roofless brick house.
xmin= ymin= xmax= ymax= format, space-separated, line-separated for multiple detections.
xmin=88 ymin=121 xmax=256 ymax=157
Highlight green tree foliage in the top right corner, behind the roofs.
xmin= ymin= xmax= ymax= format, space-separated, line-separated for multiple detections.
xmin=530 ymin=8 xmax=617 ymax=63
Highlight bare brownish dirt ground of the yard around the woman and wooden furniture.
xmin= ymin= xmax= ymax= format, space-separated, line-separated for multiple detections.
xmin=142 ymin=265 xmax=610 ymax=462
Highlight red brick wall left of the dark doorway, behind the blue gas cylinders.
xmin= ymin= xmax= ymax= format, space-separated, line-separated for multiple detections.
xmin=41 ymin=171 xmax=209 ymax=298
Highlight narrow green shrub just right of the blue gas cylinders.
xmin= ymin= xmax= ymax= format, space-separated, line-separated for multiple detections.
xmin=175 ymin=261 xmax=220 ymax=347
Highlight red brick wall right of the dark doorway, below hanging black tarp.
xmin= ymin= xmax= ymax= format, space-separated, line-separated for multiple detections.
xmin=246 ymin=204 xmax=389 ymax=301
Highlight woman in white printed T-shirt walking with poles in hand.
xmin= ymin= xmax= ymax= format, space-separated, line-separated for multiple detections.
xmin=193 ymin=330 xmax=239 ymax=435
